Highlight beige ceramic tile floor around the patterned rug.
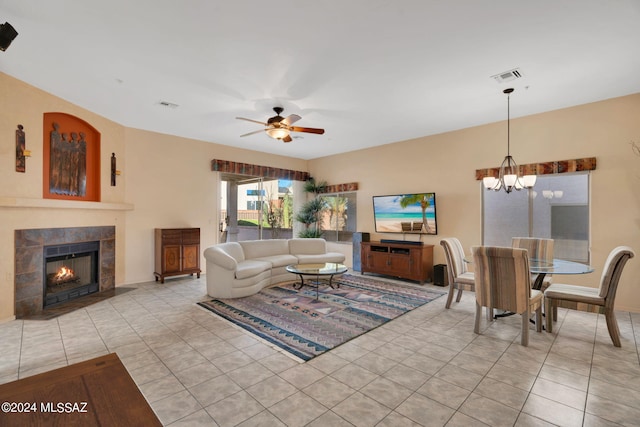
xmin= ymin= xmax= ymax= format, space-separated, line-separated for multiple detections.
xmin=0 ymin=277 xmax=640 ymax=427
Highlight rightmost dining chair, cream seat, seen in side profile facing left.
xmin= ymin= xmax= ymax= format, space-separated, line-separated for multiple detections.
xmin=544 ymin=246 xmax=635 ymax=347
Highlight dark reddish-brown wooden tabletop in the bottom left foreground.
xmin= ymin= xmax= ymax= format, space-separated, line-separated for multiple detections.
xmin=0 ymin=353 xmax=162 ymax=427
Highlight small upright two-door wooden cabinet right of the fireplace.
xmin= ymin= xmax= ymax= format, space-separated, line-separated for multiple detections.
xmin=153 ymin=228 xmax=200 ymax=283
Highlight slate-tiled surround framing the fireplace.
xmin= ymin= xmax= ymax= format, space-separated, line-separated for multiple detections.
xmin=15 ymin=226 xmax=116 ymax=318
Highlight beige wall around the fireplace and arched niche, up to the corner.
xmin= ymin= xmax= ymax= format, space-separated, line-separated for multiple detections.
xmin=0 ymin=73 xmax=307 ymax=322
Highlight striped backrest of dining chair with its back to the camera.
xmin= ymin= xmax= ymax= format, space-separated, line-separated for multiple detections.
xmin=471 ymin=246 xmax=531 ymax=313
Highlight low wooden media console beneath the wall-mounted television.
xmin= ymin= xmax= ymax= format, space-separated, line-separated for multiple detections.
xmin=360 ymin=242 xmax=433 ymax=283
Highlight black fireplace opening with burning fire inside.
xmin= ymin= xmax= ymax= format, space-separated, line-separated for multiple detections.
xmin=43 ymin=241 xmax=100 ymax=308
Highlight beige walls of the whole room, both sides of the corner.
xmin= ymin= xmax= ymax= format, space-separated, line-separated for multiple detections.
xmin=0 ymin=73 xmax=640 ymax=321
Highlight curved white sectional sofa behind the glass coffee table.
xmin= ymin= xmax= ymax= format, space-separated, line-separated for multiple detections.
xmin=204 ymin=239 xmax=345 ymax=298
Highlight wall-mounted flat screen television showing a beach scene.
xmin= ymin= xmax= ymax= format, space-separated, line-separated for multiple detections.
xmin=373 ymin=193 xmax=438 ymax=234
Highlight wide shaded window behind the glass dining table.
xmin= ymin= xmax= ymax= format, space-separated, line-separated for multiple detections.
xmin=482 ymin=173 xmax=590 ymax=262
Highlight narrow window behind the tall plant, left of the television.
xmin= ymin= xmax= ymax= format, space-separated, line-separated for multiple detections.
xmin=320 ymin=192 xmax=357 ymax=242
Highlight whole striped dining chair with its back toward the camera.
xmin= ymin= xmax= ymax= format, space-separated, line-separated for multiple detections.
xmin=471 ymin=246 xmax=542 ymax=346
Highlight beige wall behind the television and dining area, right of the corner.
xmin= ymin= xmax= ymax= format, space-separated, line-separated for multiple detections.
xmin=309 ymin=94 xmax=640 ymax=312
